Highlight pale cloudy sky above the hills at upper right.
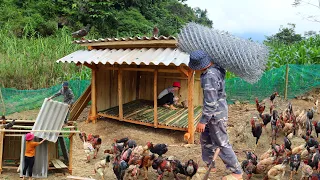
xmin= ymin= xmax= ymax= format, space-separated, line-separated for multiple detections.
xmin=186 ymin=0 xmax=320 ymax=41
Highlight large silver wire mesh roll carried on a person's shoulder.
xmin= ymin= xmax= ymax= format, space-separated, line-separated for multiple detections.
xmin=178 ymin=22 xmax=268 ymax=84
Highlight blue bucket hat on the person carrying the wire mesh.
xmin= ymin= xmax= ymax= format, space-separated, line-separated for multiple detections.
xmin=188 ymin=50 xmax=212 ymax=70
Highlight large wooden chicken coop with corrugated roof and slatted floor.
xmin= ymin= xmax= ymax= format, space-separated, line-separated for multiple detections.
xmin=57 ymin=36 xmax=203 ymax=143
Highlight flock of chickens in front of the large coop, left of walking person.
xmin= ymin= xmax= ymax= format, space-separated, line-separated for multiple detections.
xmin=83 ymin=137 xmax=198 ymax=180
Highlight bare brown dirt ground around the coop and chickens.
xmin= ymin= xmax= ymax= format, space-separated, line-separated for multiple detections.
xmin=0 ymin=90 xmax=320 ymax=180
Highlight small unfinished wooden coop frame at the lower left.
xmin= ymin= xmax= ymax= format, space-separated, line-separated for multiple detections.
xmin=0 ymin=120 xmax=79 ymax=178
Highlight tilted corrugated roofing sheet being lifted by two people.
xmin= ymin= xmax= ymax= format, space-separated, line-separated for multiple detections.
xmin=32 ymin=98 xmax=68 ymax=142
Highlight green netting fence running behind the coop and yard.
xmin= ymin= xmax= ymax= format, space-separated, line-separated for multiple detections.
xmin=0 ymin=65 xmax=320 ymax=115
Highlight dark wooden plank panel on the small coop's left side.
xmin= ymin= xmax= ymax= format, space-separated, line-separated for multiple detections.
xmin=2 ymin=136 xmax=21 ymax=160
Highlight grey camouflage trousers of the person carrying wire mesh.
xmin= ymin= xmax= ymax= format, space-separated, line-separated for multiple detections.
xmin=200 ymin=120 xmax=242 ymax=174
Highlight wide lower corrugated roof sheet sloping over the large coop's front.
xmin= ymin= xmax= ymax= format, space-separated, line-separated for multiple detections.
xmin=57 ymin=48 xmax=189 ymax=66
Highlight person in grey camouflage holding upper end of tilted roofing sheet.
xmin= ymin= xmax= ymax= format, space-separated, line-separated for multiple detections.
xmin=48 ymin=82 xmax=74 ymax=124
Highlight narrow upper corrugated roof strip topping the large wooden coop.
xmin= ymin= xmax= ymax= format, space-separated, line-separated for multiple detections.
xmin=73 ymin=36 xmax=176 ymax=44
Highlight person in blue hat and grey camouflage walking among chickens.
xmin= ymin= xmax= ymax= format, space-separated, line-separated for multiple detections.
xmin=189 ymin=50 xmax=242 ymax=180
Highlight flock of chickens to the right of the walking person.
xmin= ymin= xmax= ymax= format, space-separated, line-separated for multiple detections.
xmin=241 ymin=93 xmax=320 ymax=180
